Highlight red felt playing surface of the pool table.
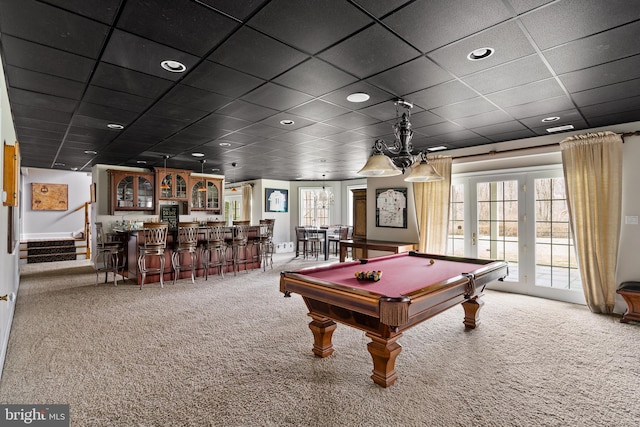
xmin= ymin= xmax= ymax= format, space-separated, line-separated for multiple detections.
xmin=298 ymin=253 xmax=482 ymax=297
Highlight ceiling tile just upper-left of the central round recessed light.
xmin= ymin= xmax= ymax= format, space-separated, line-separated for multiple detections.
xmin=274 ymin=58 xmax=358 ymax=96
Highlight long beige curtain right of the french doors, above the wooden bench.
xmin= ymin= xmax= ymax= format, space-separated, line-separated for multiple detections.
xmin=560 ymin=132 xmax=622 ymax=313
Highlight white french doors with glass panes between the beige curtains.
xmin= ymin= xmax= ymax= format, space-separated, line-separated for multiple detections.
xmin=447 ymin=167 xmax=584 ymax=304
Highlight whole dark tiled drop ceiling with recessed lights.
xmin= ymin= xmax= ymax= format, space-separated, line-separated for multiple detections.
xmin=0 ymin=0 xmax=640 ymax=181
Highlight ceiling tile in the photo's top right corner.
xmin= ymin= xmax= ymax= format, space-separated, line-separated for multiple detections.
xmin=520 ymin=0 xmax=640 ymax=50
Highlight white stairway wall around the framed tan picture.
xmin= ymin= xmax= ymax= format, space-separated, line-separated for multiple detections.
xmin=20 ymin=168 xmax=91 ymax=241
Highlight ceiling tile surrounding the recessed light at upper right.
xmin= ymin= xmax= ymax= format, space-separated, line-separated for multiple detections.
xmin=428 ymin=21 xmax=536 ymax=76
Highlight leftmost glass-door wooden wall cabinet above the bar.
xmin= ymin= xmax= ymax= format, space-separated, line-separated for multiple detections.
xmin=108 ymin=170 xmax=155 ymax=215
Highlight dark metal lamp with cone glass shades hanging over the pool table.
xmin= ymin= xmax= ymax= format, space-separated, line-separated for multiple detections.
xmin=358 ymin=99 xmax=444 ymax=182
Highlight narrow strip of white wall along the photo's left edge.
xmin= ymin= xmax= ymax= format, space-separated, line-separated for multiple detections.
xmin=0 ymin=57 xmax=22 ymax=382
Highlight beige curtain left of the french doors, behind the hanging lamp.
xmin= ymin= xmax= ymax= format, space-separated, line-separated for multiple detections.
xmin=413 ymin=156 xmax=452 ymax=254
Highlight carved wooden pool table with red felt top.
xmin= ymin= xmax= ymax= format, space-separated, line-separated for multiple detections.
xmin=280 ymin=251 xmax=508 ymax=387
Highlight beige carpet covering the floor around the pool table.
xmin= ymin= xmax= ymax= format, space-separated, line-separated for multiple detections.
xmin=0 ymin=254 xmax=640 ymax=426
